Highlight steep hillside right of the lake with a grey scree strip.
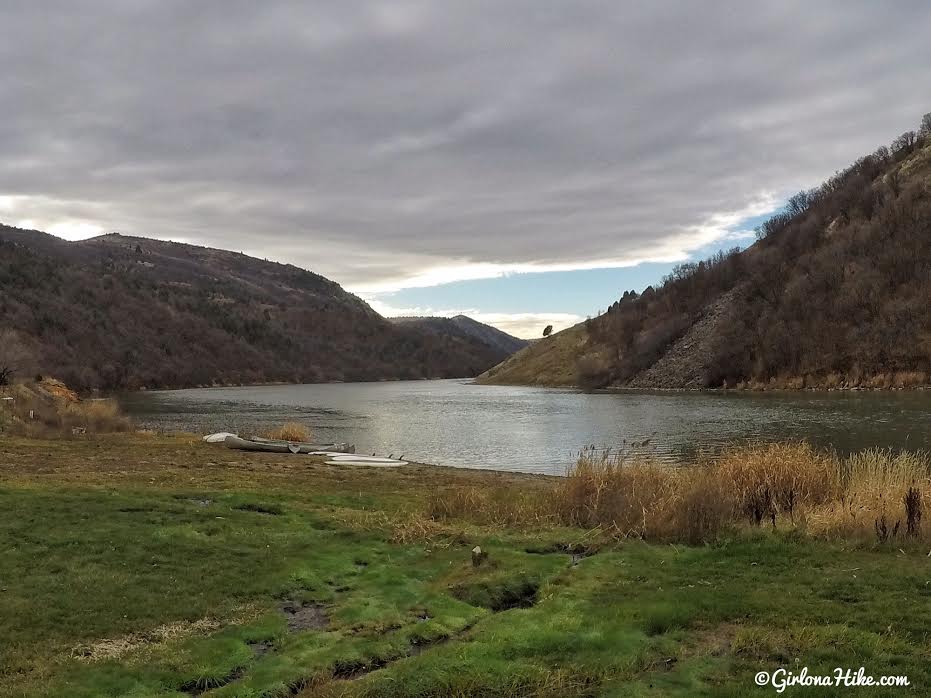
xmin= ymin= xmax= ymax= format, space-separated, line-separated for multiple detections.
xmin=478 ymin=115 xmax=931 ymax=389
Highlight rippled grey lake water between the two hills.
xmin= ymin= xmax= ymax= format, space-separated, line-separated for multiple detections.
xmin=122 ymin=380 xmax=931 ymax=474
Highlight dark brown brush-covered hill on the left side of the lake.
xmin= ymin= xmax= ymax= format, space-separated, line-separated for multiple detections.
xmin=0 ymin=226 xmax=506 ymax=390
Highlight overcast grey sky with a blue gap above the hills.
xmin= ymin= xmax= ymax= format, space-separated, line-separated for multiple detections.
xmin=0 ymin=0 xmax=931 ymax=337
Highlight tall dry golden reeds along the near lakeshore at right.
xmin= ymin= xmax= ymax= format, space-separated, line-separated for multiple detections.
xmin=426 ymin=442 xmax=931 ymax=544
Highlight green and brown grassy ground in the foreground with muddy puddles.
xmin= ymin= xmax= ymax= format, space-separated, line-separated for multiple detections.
xmin=0 ymin=435 xmax=931 ymax=697
